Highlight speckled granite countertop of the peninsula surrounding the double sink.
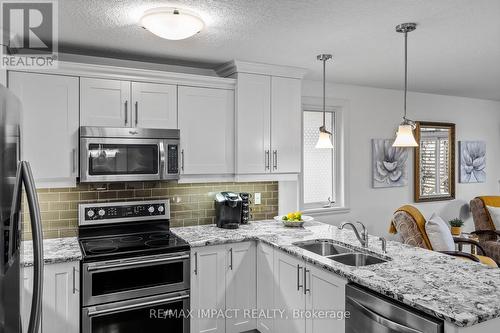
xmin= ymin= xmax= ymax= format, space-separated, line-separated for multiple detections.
xmin=171 ymin=221 xmax=500 ymax=327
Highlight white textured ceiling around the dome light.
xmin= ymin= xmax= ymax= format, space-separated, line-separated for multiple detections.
xmin=59 ymin=0 xmax=500 ymax=100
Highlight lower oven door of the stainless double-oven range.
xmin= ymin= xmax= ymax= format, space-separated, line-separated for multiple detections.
xmin=82 ymin=291 xmax=190 ymax=333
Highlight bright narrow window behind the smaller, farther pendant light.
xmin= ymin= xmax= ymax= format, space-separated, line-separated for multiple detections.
xmin=302 ymin=108 xmax=338 ymax=210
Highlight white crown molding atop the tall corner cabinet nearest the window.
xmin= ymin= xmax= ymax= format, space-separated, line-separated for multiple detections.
xmin=215 ymin=60 xmax=307 ymax=79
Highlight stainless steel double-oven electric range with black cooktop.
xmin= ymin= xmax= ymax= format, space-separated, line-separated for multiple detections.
xmin=79 ymin=200 xmax=190 ymax=333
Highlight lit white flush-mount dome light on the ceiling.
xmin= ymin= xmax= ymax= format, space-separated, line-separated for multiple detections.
xmin=141 ymin=8 xmax=205 ymax=40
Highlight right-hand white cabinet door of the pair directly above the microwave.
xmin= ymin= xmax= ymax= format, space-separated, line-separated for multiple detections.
xmin=132 ymin=82 xmax=177 ymax=128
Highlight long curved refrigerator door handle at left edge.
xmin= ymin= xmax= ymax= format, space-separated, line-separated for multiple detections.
xmin=21 ymin=161 xmax=43 ymax=333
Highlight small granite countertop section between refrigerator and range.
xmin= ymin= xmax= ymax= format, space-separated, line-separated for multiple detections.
xmin=21 ymin=237 xmax=82 ymax=267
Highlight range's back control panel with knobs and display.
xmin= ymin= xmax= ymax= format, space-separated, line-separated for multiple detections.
xmin=79 ymin=200 xmax=170 ymax=225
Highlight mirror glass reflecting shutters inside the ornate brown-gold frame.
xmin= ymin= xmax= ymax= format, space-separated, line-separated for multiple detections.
xmin=420 ymin=128 xmax=449 ymax=195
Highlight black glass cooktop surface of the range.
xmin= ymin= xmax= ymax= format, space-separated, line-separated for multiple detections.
xmin=80 ymin=230 xmax=189 ymax=260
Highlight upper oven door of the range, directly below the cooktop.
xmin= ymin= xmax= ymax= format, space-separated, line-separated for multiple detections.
xmin=82 ymin=251 xmax=190 ymax=306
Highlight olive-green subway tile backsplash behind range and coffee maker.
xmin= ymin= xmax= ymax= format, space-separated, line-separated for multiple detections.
xmin=23 ymin=182 xmax=278 ymax=239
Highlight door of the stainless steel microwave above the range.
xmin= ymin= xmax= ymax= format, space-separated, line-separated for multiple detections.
xmin=80 ymin=138 xmax=172 ymax=182
